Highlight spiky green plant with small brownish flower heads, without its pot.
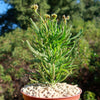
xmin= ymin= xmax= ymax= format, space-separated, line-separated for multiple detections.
xmin=26 ymin=4 xmax=82 ymax=84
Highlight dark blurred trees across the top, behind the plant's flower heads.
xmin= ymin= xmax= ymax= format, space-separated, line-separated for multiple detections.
xmin=0 ymin=0 xmax=100 ymax=34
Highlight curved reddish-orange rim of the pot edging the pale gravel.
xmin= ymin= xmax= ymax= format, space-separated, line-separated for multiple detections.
xmin=20 ymin=84 xmax=82 ymax=100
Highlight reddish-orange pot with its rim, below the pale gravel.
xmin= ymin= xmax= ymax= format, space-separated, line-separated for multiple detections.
xmin=21 ymin=88 xmax=82 ymax=100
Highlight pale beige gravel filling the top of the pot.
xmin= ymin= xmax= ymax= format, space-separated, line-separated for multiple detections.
xmin=21 ymin=83 xmax=80 ymax=98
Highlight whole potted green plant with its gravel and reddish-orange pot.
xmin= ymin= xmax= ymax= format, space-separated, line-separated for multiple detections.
xmin=21 ymin=4 xmax=82 ymax=100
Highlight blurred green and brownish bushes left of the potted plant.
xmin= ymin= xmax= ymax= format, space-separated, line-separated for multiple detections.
xmin=0 ymin=29 xmax=33 ymax=100
